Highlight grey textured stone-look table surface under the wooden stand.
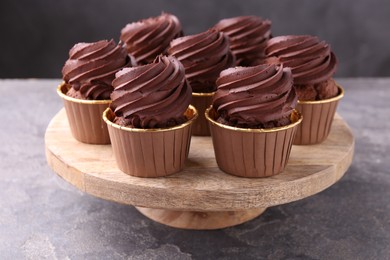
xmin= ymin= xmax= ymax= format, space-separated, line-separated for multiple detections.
xmin=0 ymin=78 xmax=390 ymax=259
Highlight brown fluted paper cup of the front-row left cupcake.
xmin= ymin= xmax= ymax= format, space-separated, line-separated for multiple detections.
xmin=103 ymin=105 xmax=198 ymax=177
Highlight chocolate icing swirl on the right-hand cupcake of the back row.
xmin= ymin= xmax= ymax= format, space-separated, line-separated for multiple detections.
xmin=214 ymin=15 xmax=271 ymax=66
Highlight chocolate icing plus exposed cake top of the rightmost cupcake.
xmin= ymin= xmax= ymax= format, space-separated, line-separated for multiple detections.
xmin=264 ymin=35 xmax=338 ymax=100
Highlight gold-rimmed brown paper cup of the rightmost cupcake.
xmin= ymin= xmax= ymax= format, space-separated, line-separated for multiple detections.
xmin=293 ymin=86 xmax=344 ymax=145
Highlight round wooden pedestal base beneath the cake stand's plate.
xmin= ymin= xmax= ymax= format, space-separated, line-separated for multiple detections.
xmin=135 ymin=207 xmax=266 ymax=230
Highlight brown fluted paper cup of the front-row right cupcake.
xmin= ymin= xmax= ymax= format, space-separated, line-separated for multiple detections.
xmin=206 ymin=107 xmax=302 ymax=178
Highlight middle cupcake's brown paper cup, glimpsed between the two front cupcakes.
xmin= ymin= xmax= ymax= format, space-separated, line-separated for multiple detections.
xmin=191 ymin=92 xmax=215 ymax=136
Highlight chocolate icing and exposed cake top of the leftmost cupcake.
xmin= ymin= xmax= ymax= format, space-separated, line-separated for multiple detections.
xmin=62 ymin=40 xmax=134 ymax=100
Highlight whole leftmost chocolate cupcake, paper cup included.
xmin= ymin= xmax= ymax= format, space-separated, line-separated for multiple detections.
xmin=57 ymin=40 xmax=134 ymax=144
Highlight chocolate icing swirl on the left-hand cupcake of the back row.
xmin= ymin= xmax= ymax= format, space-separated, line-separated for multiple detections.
xmin=120 ymin=13 xmax=183 ymax=64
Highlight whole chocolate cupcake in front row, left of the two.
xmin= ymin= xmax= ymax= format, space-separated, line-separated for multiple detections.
xmin=103 ymin=56 xmax=197 ymax=177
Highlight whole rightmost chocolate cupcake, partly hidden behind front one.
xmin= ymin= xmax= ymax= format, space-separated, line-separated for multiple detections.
xmin=265 ymin=35 xmax=344 ymax=144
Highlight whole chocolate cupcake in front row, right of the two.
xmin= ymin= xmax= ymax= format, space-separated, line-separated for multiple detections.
xmin=206 ymin=65 xmax=302 ymax=177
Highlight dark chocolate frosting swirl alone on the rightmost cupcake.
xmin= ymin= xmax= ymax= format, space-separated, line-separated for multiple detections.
xmin=265 ymin=35 xmax=337 ymax=85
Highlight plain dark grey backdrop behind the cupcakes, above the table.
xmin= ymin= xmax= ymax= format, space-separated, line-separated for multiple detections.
xmin=0 ymin=0 xmax=390 ymax=78
